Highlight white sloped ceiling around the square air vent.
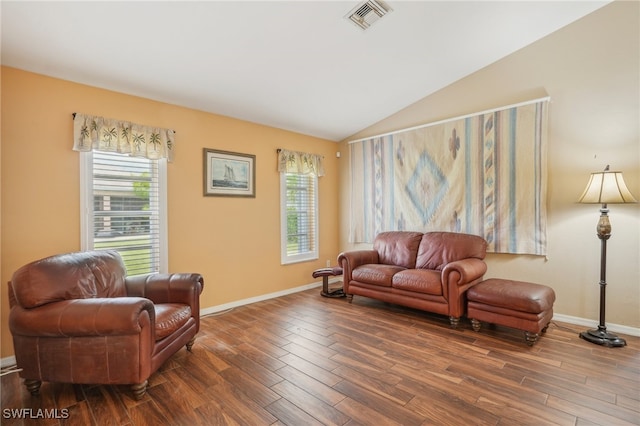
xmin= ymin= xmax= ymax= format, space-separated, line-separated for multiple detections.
xmin=1 ymin=0 xmax=608 ymax=141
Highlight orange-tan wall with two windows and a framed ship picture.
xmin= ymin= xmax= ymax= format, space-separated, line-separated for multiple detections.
xmin=0 ymin=67 xmax=338 ymax=357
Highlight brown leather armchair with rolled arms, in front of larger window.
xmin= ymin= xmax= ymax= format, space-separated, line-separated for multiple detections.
xmin=9 ymin=251 xmax=204 ymax=399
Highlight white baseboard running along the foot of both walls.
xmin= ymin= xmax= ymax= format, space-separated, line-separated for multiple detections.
xmin=0 ymin=278 xmax=640 ymax=368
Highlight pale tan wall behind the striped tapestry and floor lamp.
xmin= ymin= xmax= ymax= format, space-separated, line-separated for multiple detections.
xmin=339 ymin=2 xmax=640 ymax=327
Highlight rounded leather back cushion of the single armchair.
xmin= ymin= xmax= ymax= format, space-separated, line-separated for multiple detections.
xmin=11 ymin=251 xmax=126 ymax=309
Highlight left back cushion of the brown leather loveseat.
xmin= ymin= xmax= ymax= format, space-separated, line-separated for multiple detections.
xmin=373 ymin=231 xmax=422 ymax=268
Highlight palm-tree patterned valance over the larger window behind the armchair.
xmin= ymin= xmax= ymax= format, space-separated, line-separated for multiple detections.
xmin=73 ymin=114 xmax=175 ymax=161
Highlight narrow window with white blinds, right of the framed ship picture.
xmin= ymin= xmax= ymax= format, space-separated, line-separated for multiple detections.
xmin=280 ymin=172 xmax=318 ymax=264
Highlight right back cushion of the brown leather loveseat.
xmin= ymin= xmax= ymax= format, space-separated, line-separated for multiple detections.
xmin=416 ymin=232 xmax=487 ymax=271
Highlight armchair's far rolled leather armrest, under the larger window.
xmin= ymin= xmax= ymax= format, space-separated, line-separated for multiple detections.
xmin=125 ymin=273 xmax=204 ymax=308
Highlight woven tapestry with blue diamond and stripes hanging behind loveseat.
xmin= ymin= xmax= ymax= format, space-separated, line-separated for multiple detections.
xmin=349 ymin=99 xmax=548 ymax=255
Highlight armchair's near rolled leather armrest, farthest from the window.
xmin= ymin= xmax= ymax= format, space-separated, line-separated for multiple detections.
xmin=9 ymin=297 xmax=155 ymax=337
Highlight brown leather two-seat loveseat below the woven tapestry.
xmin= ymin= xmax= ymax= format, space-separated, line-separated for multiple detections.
xmin=338 ymin=231 xmax=487 ymax=328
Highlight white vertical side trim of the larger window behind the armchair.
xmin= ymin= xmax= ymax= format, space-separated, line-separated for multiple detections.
xmin=79 ymin=151 xmax=169 ymax=273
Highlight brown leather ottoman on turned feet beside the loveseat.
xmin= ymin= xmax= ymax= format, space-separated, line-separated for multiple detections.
xmin=467 ymin=278 xmax=556 ymax=346
